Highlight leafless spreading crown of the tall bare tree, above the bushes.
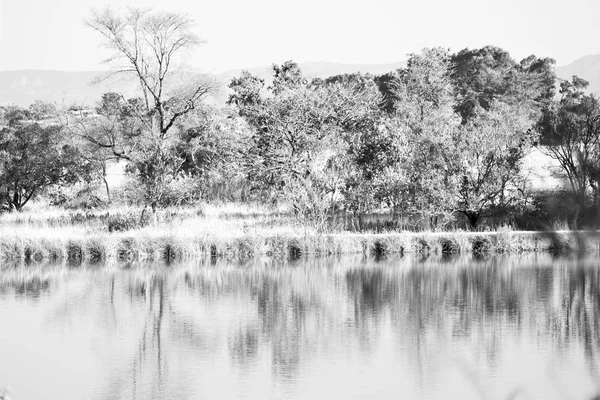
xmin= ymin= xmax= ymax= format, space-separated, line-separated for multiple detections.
xmin=87 ymin=8 xmax=216 ymax=136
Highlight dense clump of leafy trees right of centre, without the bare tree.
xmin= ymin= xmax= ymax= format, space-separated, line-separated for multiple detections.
xmin=230 ymin=48 xmax=554 ymax=227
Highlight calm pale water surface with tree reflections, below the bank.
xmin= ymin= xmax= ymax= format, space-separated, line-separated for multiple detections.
xmin=0 ymin=255 xmax=600 ymax=400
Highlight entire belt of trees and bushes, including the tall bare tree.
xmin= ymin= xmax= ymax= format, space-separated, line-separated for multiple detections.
xmin=0 ymin=9 xmax=600 ymax=228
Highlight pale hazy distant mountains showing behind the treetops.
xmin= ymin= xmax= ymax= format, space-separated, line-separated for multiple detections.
xmin=0 ymin=54 xmax=600 ymax=106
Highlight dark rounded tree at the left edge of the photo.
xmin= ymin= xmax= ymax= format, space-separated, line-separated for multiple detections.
xmin=0 ymin=115 xmax=92 ymax=211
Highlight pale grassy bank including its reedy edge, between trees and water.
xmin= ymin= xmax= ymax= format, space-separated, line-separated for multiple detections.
xmin=0 ymin=204 xmax=600 ymax=264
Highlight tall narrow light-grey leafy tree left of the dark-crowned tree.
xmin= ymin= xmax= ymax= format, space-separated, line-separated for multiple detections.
xmin=377 ymin=48 xmax=460 ymax=226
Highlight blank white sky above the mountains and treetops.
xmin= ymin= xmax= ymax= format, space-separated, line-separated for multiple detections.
xmin=0 ymin=0 xmax=600 ymax=72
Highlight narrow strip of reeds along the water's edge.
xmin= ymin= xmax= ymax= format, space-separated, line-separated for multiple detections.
xmin=0 ymin=230 xmax=600 ymax=264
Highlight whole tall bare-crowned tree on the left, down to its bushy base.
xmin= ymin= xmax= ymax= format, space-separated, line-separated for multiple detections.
xmin=87 ymin=8 xmax=216 ymax=211
